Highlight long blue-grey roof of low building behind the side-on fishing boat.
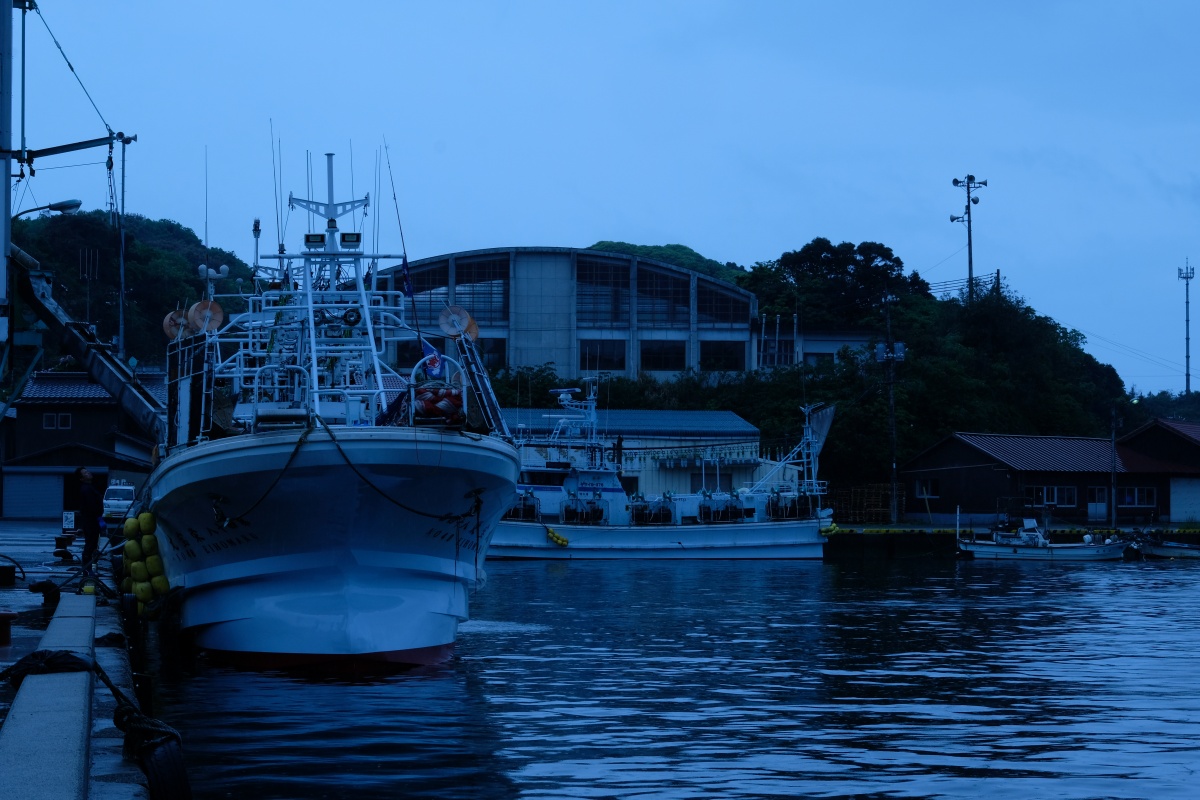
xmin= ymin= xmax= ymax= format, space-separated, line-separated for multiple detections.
xmin=502 ymin=408 xmax=758 ymax=440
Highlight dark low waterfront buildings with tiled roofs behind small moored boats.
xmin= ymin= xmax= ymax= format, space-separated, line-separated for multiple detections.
xmin=900 ymin=420 xmax=1200 ymax=527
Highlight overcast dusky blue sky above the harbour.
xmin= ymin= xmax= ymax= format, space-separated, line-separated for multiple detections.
xmin=13 ymin=0 xmax=1200 ymax=393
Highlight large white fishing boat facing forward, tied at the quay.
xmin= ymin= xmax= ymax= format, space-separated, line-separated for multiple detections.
xmin=134 ymin=155 xmax=520 ymax=664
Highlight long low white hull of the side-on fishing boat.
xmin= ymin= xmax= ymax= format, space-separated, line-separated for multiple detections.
xmin=488 ymin=519 xmax=826 ymax=560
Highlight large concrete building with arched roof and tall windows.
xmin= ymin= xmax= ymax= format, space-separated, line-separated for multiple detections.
xmin=382 ymin=247 xmax=757 ymax=378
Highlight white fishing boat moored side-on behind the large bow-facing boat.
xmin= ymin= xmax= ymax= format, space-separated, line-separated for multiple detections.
xmin=488 ymin=379 xmax=833 ymax=559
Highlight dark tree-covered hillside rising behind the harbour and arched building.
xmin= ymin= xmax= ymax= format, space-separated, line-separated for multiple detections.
xmin=5 ymin=211 xmax=1176 ymax=485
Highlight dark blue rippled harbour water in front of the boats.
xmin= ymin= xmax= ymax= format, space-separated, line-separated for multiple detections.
xmin=156 ymin=559 xmax=1200 ymax=800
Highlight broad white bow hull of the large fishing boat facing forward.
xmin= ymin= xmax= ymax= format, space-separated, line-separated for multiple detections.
xmin=148 ymin=427 xmax=518 ymax=664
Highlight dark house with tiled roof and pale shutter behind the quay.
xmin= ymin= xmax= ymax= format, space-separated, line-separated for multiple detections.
xmin=0 ymin=371 xmax=166 ymax=519
